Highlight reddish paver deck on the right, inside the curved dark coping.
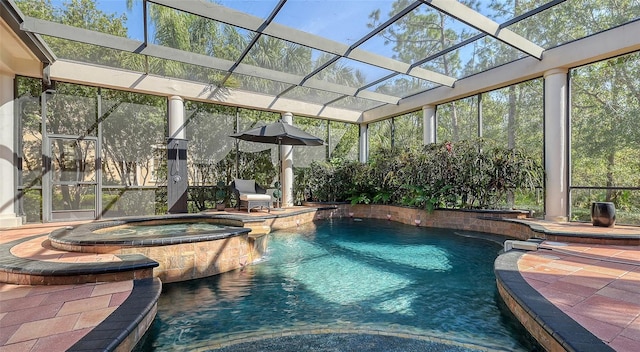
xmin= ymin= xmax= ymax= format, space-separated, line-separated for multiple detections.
xmin=518 ymin=241 xmax=640 ymax=352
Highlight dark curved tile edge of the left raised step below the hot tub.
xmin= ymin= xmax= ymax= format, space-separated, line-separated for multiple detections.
xmin=0 ymin=234 xmax=159 ymax=277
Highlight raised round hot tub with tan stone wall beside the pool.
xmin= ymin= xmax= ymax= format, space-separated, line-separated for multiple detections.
xmin=49 ymin=215 xmax=266 ymax=283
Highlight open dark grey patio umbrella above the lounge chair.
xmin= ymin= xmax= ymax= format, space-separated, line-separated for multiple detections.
xmin=230 ymin=120 xmax=324 ymax=207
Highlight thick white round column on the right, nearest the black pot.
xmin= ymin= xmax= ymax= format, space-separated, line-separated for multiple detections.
xmin=544 ymin=69 xmax=569 ymax=221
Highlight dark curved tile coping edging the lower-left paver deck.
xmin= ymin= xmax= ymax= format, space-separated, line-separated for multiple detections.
xmin=67 ymin=278 xmax=162 ymax=351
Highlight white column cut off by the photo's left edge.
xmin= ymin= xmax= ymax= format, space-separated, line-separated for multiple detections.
xmin=0 ymin=73 xmax=22 ymax=228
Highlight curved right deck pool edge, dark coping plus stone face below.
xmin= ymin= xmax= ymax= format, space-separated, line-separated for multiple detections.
xmin=494 ymin=250 xmax=614 ymax=352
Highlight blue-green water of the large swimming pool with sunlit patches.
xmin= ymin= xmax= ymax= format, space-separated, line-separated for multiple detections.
xmin=138 ymin=219 xmax=532 ymax=351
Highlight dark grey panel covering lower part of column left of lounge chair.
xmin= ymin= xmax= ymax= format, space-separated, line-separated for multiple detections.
xmin=167 ymin=138 xmax=188 ymax=214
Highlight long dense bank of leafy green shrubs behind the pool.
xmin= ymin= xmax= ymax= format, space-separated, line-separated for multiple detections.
xmin=305 ymin=139 xmax=543 ymax=211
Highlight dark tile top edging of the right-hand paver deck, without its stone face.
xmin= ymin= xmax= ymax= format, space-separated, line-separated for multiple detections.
xmin=494 ymin=250 xmax=614 ymax=352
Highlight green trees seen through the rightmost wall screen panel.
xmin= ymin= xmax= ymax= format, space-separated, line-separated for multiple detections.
xmin=572 ymin=54 xmax=640 ymax=207
